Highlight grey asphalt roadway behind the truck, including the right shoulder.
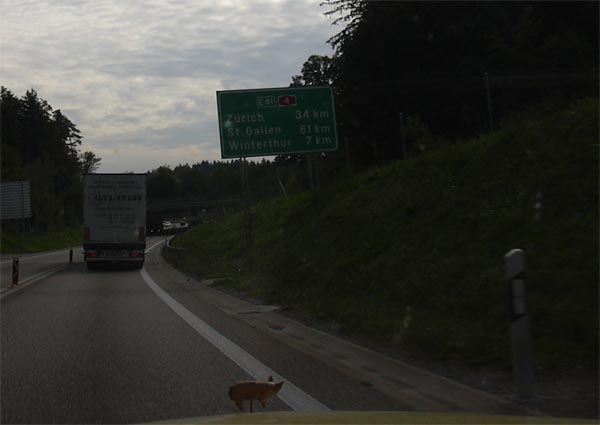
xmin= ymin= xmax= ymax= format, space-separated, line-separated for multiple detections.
xmin=0 ymin=238 xmax=411 ymax=423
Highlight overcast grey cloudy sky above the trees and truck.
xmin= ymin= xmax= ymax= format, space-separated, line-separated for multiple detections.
xmin=0 ymin=0 xmax=342 ymax=172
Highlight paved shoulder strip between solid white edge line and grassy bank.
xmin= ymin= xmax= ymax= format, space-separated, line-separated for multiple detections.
xmin=144 ymin=240 xmax=544 ymax=416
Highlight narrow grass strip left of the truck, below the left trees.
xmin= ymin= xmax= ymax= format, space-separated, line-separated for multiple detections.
xmin=0 ymin=227 xmax=83 ymax=254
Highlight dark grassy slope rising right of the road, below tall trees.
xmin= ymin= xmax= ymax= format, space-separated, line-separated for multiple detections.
xmin=171 ymin=100 xmax=599 ymax=369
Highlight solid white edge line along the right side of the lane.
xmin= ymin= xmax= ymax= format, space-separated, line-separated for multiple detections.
xmin=140 ymin=264 xmax=331 ymax=412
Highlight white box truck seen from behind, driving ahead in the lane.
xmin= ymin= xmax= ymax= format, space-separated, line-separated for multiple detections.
xmin=83 ymin=174 xmax=146 ymax=269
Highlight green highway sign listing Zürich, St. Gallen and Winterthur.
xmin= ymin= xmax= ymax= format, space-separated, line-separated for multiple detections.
xmin=217 ymin=87 xmax=338 ymax=158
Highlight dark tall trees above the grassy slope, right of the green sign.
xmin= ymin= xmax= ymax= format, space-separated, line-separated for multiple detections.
xmin=287 ymin=0 xmax=598 ymax=166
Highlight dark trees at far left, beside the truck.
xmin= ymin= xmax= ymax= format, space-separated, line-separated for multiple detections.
xmin=0 ymin=87 xmax=100 ymax=231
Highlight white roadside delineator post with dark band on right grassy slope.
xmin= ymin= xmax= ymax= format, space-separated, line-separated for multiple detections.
xmin=504 ymin=249 xmax=533 ymax=398
